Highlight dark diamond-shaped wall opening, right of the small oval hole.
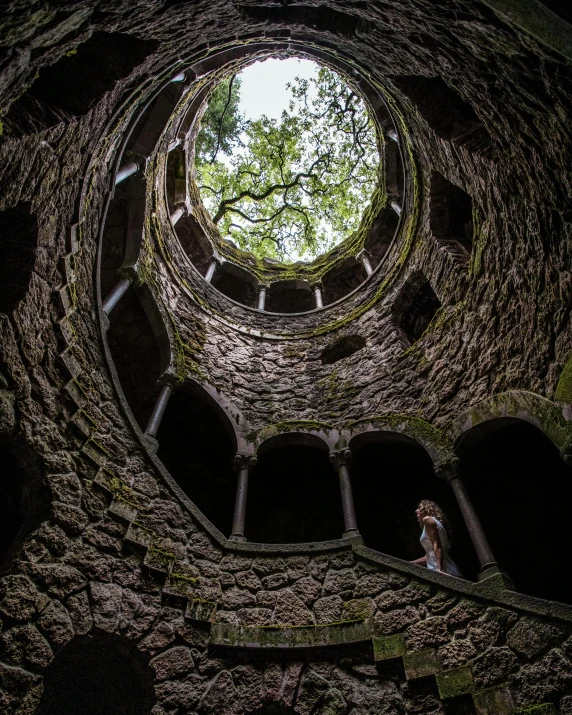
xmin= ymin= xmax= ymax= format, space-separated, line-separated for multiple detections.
xmin=391 ymin=272 xmax=441 ymax=345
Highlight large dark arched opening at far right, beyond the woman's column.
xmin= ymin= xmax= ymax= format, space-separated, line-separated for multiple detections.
xmin=456 ymin=418 xmax=572 ymax=603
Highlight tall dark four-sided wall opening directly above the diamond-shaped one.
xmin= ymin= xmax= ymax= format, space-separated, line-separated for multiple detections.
xmin=430 ymin=171 xmax=473 ymax=259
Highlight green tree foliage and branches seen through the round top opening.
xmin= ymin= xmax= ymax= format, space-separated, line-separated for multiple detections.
xmin=196 ymin=67 xmax=379 ymax=260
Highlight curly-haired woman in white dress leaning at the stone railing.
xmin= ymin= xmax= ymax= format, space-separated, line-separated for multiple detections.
xmin=411 ymin=499 xmax=463 ymax=578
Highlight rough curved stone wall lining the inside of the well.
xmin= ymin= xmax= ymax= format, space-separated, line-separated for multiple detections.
xmin=0 ymin=0 xmax=572 ymax=715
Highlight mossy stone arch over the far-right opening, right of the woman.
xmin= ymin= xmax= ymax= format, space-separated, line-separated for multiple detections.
xmin=450 ymin=390 xmax=572 ymax=452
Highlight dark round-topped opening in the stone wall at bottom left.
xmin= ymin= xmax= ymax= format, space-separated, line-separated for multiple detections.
xmin=36 ymin=634 xmax=155 ymax=715
